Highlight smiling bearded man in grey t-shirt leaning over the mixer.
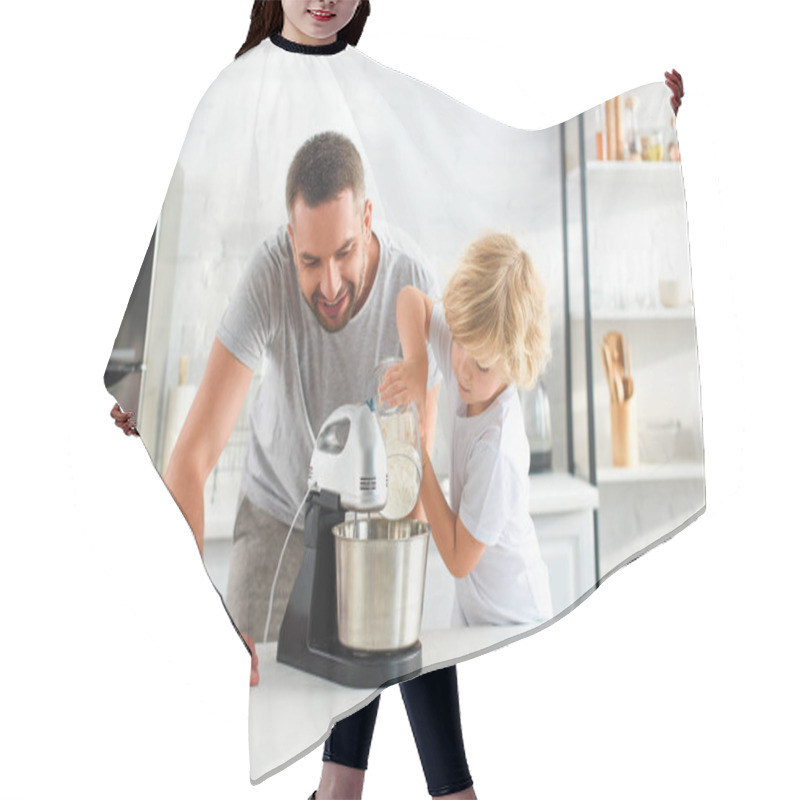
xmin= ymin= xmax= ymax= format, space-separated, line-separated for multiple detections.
xmin=164 ymin=133 xmax=438 ymax=668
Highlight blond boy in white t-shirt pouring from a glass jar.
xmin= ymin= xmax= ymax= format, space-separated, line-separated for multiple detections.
xmin=381 ymin=234 xmax=552 ymax=625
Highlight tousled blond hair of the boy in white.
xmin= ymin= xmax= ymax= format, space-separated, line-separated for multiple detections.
xmin=442 ymin=233 xmax=550 ymax=388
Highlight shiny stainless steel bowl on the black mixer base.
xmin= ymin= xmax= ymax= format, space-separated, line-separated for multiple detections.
xmin=333 ymin=518 xmax=430 ymax=651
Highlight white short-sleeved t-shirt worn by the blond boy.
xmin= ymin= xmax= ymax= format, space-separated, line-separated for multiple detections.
xmin=429 ymin=303 xmax=553 ymax=625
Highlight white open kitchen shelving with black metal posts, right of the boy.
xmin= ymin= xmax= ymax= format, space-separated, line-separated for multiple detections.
xmin=562 ymin=84 xmax=705 ymax=578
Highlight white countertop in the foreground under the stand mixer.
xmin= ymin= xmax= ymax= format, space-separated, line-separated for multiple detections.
xmin=249 ymin=625 xmax=534 ymax=782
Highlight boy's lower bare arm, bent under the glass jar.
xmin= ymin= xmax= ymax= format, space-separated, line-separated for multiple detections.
xmin=420 ymin=448 xmax=486 ymax=578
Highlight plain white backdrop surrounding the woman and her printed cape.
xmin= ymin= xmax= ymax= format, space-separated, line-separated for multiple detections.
xmin=0 ymin=0 xmax=800 ymax=799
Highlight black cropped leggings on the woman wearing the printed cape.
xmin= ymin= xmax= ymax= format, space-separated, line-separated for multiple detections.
xmin=322 ymin=666 xmax=472 ymax=797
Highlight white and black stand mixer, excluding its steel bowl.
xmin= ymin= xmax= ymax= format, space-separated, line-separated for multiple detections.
xmin=277 ymin=404 xmax=427 ymax=688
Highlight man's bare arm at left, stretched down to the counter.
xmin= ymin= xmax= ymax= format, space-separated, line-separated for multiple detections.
xmin=164 ymin=339 xmax=253 ymax=555
